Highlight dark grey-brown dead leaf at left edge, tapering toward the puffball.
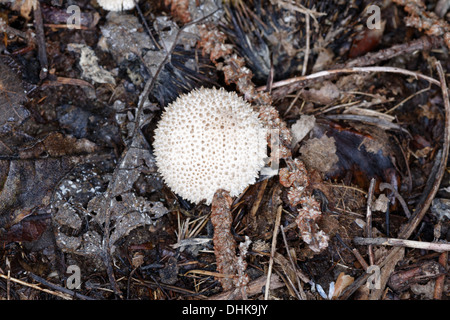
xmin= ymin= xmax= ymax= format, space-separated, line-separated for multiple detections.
xmin=0 ymin=133 xmax=95 ymax=241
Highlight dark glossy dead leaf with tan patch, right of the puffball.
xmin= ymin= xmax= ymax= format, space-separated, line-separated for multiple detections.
xmin=308 ymin=122 xmax=403 ymax=192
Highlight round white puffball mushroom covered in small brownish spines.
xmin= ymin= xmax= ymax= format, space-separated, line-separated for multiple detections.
xmin=153 ymin=88 xmax=267 ymax=204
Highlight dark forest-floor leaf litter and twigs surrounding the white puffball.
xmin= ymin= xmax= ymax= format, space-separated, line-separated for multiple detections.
xmin=0 ymin=0 xmax=450 ymax=300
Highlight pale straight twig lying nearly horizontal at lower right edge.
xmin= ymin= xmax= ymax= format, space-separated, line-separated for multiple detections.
xmin=353 ymin=237 xmax=450 ymax=252
